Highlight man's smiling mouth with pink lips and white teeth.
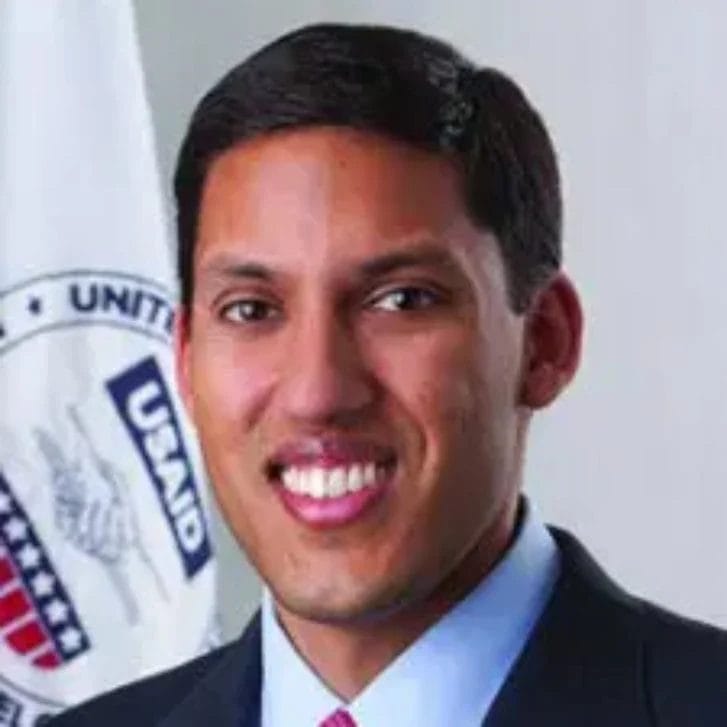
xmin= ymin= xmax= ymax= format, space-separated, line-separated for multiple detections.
xmin=267 ymin=441 xmax=397 ymax=528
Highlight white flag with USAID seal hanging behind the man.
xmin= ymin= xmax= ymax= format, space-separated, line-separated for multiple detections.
xmin=0 ymin=0 xmax=215 ymax=727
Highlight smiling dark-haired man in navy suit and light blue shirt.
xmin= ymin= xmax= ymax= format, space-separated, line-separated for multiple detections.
xmin=55 ymin=25 xmax=727 ymax=727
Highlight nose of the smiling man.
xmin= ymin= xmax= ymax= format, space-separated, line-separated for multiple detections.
xmin=278 ymin=312 xmax=377 ymax=426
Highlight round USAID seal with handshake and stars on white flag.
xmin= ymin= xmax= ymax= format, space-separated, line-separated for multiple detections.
xmin=0 ymin=270 xmax=214 ymax=727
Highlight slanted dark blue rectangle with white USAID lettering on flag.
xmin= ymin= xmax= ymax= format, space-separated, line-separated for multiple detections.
xmin=106 ymin=357 xmax=210 ymax=578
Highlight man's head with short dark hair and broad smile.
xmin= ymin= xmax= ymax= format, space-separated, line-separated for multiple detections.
xmin=175 ymin=26 xmax=580 ymax=622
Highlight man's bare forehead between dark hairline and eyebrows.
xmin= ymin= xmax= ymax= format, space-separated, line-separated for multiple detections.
xmin=195 ymin=127 xmax=498 ymax=278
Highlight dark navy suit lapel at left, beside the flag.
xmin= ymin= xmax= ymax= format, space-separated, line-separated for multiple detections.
xmin=158 ymin=613 xmax=262 ymax=727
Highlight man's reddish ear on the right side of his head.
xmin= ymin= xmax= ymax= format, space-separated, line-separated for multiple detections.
xmin=520 ymin=273 xmax=583 ymax=409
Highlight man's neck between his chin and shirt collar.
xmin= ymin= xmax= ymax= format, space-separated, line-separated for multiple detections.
xmin=277 ymin=499 xmax=517 ymax=702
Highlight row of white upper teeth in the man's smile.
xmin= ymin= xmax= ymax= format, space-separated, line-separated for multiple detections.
xmin=281 ymin=462 xmax=386 ymax=499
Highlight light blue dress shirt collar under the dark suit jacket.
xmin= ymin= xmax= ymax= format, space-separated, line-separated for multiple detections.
xmin=262 ymin=503 xmax=560 ymax=727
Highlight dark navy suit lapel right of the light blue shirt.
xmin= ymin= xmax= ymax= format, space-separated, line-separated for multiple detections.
xmin=483 ymin=530 xmax=649 ymax=727
